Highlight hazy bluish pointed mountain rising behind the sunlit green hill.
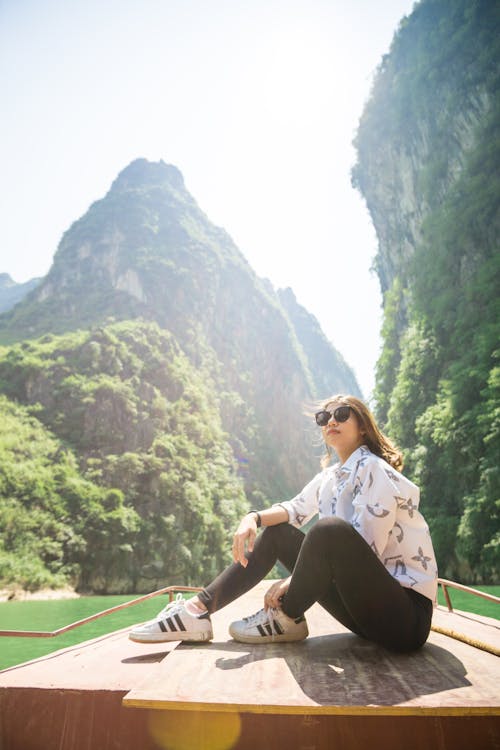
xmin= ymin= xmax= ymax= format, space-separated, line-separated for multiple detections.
xmin=0 ymin=159 xmax=359 ymax=494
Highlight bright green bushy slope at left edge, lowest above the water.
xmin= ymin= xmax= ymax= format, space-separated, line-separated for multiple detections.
xmin=0 ymin=396 xmax=139 ymax=589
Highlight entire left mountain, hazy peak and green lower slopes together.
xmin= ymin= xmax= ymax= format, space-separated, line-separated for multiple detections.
xmin=0 ymin=159 xmax=359 ymax=591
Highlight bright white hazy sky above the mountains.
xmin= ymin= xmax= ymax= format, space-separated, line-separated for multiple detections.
xmin=0 ymin=0 xmax=414 ymax=399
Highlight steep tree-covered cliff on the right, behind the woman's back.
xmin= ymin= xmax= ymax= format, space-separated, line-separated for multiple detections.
xmin=353 ymin=0 xmax=500 ymax=582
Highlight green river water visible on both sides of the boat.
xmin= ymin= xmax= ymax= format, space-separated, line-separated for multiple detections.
xmin=0 ymin=586 xmax=500 ymax=669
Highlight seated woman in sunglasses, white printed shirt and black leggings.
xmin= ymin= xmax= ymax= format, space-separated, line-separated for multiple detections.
xmin=130 ymin=395 xmax=437 ymax=652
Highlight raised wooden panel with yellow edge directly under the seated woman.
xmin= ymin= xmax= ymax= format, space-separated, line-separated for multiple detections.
xmin=124 ymin=581 xmax=500 ymax=716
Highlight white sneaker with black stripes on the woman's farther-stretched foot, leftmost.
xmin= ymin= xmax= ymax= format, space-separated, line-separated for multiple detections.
xmin=128 ymin=594 xmax=214 ymax=643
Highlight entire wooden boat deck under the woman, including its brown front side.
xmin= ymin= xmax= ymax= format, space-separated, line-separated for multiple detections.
xmin=0 ymin=582 xmax=500 ymax=750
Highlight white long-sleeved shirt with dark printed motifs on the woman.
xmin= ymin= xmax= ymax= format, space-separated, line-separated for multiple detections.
xmin=279 ymin=445 xmax=437 ymax=602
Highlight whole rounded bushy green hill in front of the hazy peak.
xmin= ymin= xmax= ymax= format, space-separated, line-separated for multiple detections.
xmin=0 ymin=322 xmax=248 ymax=591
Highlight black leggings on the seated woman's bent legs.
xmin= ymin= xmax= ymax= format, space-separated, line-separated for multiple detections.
xmin=198 ymin=518 xmax=433 ymax=651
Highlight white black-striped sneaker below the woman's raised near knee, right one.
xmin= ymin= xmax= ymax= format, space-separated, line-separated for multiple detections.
xmin=229 ymin=608 xmax=309 ymax=643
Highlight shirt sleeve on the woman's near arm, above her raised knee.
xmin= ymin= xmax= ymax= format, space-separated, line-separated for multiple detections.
xmin=351 ymin=462 xmax=399 ymax=557
